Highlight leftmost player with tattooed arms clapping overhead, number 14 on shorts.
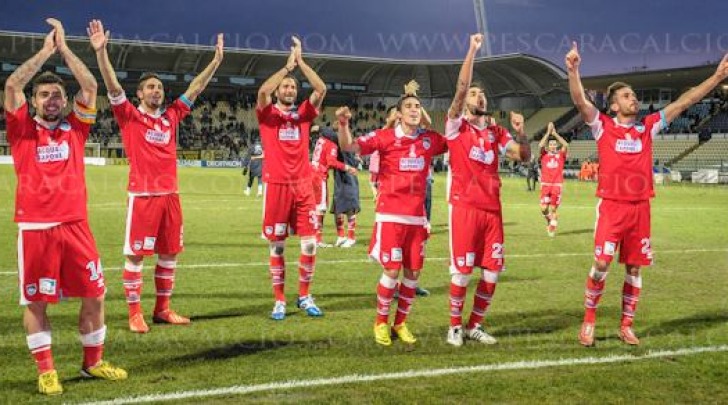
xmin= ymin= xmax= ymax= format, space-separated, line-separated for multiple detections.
xmin=4 ymin=18 xmax=127 ymax=395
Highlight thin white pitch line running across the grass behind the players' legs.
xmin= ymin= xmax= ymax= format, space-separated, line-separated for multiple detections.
xmin=0 ymin=249 xmax=728 ymax=276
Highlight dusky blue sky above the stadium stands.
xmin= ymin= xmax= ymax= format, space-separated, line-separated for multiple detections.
xmin=0 ymin=0 xmax=728 ymax=75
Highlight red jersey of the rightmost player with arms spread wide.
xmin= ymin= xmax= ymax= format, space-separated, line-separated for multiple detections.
xmin=589 ymin=111 xmax=667 ymax=201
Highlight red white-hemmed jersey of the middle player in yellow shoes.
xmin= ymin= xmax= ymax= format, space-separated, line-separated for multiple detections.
xmin=356 ymin=126 xmax=447 ymax=225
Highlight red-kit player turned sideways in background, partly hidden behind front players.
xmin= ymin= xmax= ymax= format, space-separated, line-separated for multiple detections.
xmin=311 ymin=128 xmax=357 ymax=247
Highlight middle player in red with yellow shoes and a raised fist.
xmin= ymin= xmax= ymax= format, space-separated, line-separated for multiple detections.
xmin=336 ymin=90 xmax=447 ymax=346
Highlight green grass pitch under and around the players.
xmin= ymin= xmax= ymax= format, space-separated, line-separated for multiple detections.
xmin=0 ymin=166 xmax=728 ymax=403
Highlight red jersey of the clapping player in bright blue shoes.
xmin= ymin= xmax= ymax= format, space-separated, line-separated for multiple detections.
xmin=255 ymin=100 xmax=318 ymax=184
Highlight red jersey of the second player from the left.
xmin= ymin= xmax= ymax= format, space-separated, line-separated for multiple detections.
xmin=109 ymin=93 xmax=192 ymax=194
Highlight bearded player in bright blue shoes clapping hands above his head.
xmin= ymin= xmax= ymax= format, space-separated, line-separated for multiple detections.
xmin=256 ymin=37 xmax=326 ymax=320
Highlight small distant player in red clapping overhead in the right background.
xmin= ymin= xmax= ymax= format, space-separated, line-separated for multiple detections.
xmin=538 ymin=122 xmax=569 ymax=237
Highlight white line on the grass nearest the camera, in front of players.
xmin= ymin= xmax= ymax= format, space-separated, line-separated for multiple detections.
xmin=79 ymin=345 xmax=728 ymax=404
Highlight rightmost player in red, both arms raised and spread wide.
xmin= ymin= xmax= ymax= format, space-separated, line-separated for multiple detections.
xmin=565 ymin=43 xmax=728 ymax=346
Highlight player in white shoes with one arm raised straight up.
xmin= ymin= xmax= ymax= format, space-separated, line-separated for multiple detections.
xmin=445 ymin=34 xmax=531 ymax=346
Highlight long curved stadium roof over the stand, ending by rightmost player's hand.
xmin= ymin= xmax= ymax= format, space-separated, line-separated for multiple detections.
xmin=0 ymin=32 xmax=565 ymax=97
